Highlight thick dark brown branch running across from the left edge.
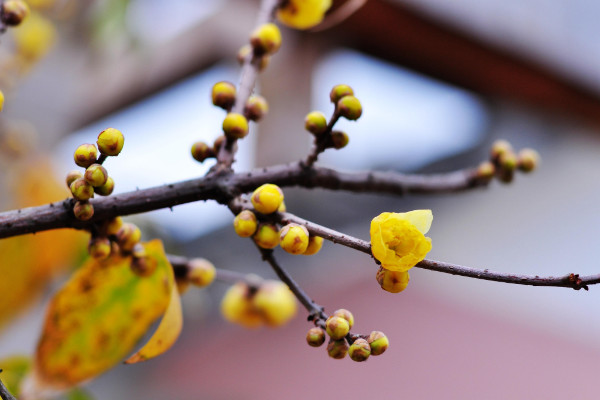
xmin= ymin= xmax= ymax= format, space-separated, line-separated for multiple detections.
xmin=0 ymin=163 xmax=487 ymax=238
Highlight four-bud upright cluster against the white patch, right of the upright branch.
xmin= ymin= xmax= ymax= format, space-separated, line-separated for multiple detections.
xmin=304 ymin=85 xmax=362 ymax=151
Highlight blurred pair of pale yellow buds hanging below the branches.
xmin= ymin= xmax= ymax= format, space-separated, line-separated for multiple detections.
xmin=221 ymin=276 xmax=297 ymax=328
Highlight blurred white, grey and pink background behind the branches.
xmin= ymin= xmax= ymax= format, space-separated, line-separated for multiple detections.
xmin=0 ymin=0 xmax=600 ymax=400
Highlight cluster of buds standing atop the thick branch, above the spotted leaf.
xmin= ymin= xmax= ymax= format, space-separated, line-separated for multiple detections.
xmin=66 ymin=128 xmax=125 ymax=221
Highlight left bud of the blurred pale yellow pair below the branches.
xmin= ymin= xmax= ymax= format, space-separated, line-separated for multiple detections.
xmin=221 ymin=282 xmax=263 ymax=328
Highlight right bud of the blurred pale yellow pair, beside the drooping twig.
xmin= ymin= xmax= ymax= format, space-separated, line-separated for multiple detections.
xmin=252 ymin=280 xmax=297 ymax=327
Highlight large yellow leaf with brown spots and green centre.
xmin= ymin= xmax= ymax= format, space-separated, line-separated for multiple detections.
xmin=32 ymin=240 xmax=175 ymax=390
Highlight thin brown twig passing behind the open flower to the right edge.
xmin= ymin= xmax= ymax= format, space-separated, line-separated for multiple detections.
xmin=278 ymin=213 xmax=600 ymax=290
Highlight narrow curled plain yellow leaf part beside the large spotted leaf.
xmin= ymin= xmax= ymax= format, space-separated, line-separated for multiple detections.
xmin=125 ymin=285 xmax=183 ymax=364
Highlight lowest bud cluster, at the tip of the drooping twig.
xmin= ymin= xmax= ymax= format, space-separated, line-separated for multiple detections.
xmin=306 ymin=309 xmax=389 ymax=362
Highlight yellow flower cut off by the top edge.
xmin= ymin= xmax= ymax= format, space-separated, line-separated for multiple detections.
xmin=277 ymin=0 xmax=331 ymax=29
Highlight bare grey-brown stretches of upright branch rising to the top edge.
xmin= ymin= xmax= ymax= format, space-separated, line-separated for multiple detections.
xmin=215 ymin=0 xmax=279 ymax=171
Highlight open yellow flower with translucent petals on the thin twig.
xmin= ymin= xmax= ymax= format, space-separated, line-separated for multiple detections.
xmin=371 ymin=210 xmax=433 ymax=271
